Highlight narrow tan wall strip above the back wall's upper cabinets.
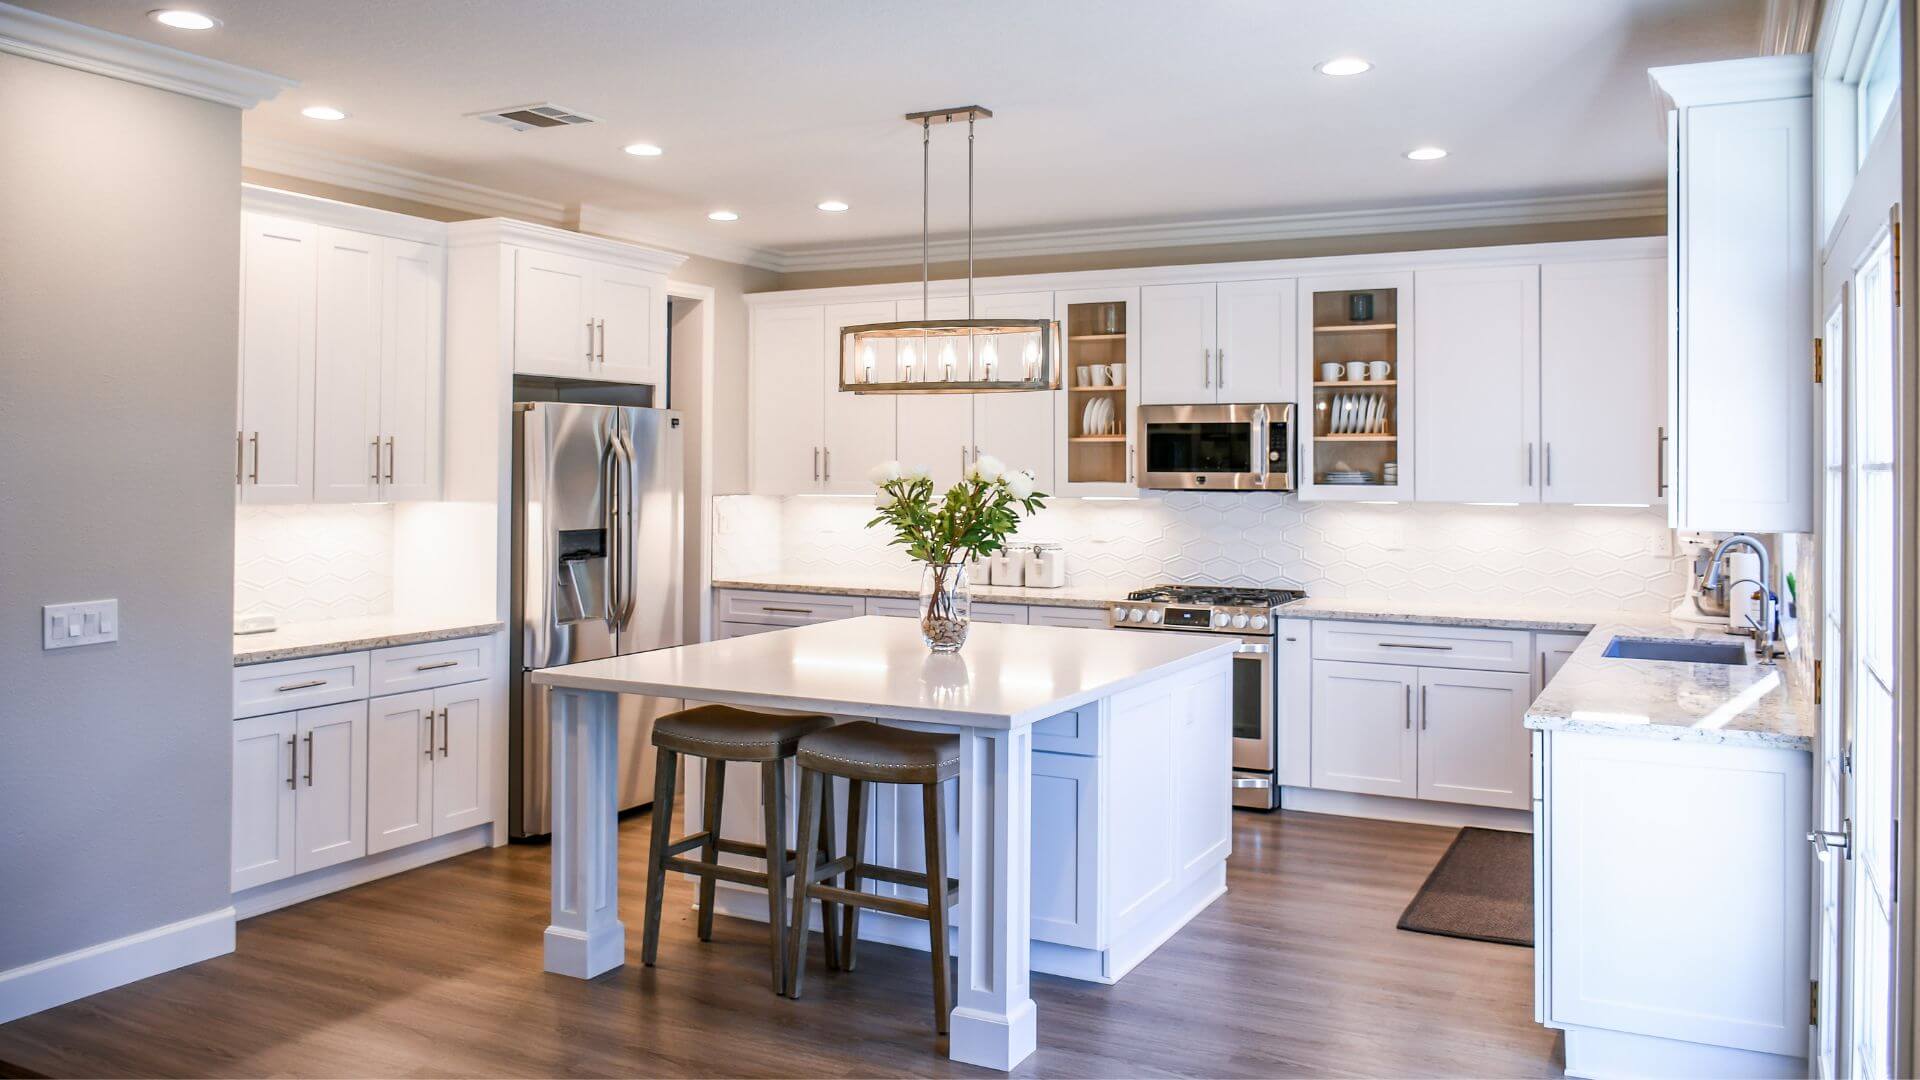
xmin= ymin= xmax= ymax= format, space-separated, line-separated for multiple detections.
xmin=780 ymin=217 xmax=1667 ymax=290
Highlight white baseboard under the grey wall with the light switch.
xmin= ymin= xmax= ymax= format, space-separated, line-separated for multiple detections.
xmin=0 ymin=907 xmax=234 ymax=1024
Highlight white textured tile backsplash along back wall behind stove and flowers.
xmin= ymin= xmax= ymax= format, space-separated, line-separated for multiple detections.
xmin=714 ymin=492 xmax=1686 ymax=613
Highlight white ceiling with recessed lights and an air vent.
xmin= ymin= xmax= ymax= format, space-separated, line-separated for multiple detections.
xmin=25 ymin=0 xmax=1766 ymax=267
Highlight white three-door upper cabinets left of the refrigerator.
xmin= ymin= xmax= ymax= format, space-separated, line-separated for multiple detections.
xmin=234 ymin=186 xmax=445 ymax=503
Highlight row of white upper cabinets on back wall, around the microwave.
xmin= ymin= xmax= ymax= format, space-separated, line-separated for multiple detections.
xmin=747 ymin=238 xmax=1667 ymax=505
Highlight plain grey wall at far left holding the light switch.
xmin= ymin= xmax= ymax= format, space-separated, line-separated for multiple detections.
xmin=0 ymin=56 xmax=240 ymax=970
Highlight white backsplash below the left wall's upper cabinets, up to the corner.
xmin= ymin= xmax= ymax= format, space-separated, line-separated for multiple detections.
xmin=234 ymin=503 xmax=394 ymax=623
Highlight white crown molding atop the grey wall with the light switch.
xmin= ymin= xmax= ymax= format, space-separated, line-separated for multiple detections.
xmin=0 ymin=4 xmax=288 ymax=110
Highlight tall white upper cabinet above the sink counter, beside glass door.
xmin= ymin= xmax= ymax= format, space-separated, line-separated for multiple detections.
xmin=1649 ymin=54 xmax=1814 ymax=532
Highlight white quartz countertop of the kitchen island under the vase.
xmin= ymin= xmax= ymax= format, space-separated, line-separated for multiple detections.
xmin=534 ymin=615 xmax=1238 ymax=728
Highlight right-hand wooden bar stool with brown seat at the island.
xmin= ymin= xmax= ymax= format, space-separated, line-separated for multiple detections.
xmin=787 ymin=721 xmax=960 ymax=1034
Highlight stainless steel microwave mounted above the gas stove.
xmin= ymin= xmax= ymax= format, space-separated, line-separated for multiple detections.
xmin=1135 ymin=404 xmax=1294 ymax=492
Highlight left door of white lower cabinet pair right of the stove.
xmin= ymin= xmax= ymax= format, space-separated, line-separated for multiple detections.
xmin=1311 ymin=659 xmax=1428 ymax=799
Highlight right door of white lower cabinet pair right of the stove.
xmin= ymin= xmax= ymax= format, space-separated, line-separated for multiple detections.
xmin=1417 ymin=667 xmax=1532 ymax=809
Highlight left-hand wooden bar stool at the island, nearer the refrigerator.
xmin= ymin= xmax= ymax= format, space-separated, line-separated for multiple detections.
xmin=639 ymin=705 xmax=837 ymax=994
